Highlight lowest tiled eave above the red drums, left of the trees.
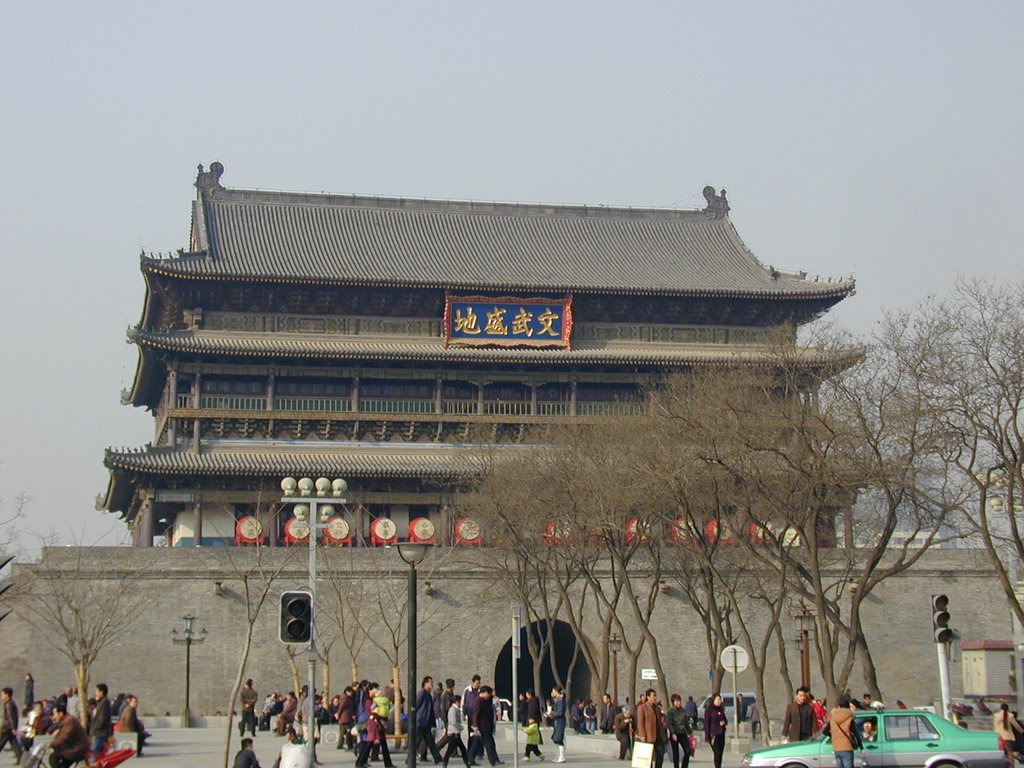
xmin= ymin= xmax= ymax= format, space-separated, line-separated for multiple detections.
xmin=103 ymin=441 xmax=482 ymax=479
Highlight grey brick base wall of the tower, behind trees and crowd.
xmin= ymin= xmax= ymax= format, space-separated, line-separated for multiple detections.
xmin=0 ymin=548 xmax=1011 ymax=717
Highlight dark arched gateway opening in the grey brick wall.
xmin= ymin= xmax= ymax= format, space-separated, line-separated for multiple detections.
xmin=495 ymin=621 xmax=591 ymax=701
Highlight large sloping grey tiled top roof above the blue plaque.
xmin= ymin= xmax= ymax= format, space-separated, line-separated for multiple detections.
xmin=143 ymin=182 xmax=854 ymax=303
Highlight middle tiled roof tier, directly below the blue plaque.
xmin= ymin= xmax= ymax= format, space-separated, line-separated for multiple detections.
xmin=132 ymin=331 xmax=861 ymax=367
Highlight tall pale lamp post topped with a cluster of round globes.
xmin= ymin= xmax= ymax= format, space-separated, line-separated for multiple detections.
xmin=281 ymin=477 xmax=348 ymax=751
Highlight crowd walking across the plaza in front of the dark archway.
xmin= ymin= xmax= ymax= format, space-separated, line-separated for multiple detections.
xmin=233 ymin=675 xmax=712 ymax=768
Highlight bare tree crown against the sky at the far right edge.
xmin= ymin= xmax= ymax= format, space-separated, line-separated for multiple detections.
xmin=884 ymin=281 xmax=1024 ymax=623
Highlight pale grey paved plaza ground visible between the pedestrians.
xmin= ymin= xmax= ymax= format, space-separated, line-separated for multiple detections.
xmin=18 ymin=726 xmax=742 ymax=768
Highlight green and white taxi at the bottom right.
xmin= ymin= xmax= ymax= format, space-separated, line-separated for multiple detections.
xmin=743 ymin=710 xmax=1007 ymax=768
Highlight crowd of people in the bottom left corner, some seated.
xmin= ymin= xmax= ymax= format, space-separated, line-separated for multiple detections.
xmin=0 ymin=673 xmax=150 ymax=768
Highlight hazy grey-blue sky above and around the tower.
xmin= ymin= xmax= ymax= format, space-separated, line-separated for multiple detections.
xmin=0 ymin=0 xmax=1024 ymax=544
